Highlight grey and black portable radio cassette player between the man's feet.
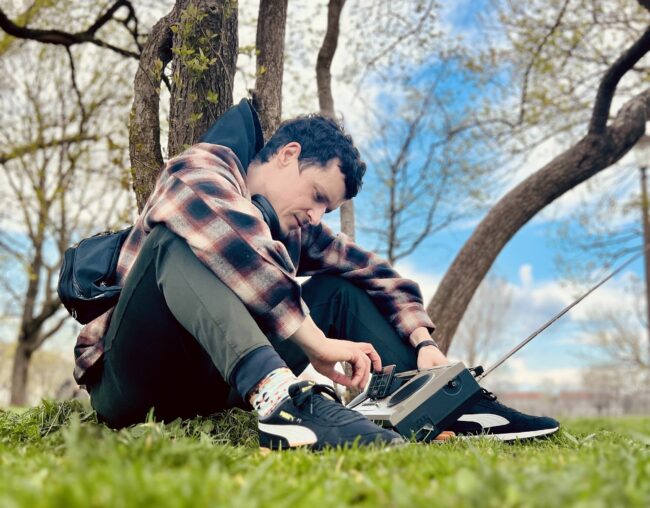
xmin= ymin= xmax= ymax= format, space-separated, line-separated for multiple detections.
xmin=347 ymin=362 xmax=481 ymax=442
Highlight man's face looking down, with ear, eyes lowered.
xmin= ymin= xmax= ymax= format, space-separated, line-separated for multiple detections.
xmin=261 ymin=143 xmax=345 ymax=235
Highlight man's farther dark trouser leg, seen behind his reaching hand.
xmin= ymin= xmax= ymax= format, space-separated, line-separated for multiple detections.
xmin=276 ymin=275 xmax=417 ymax=374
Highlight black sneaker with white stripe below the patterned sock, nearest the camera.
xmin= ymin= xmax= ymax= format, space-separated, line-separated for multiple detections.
xmin=258 ymin=381 xmax=404 ymax=450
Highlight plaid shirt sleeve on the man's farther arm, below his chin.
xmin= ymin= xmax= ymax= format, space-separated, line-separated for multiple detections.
xmin=298 ymin=224 xmax=435 ymax=340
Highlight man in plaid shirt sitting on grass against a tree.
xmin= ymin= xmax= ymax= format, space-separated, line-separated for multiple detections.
xmin=75 ymin=100 xmax=558 ymax=449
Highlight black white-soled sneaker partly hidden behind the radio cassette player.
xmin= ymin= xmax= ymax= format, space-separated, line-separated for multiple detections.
xmin=447 ymin=388 xmax=560 ymax=441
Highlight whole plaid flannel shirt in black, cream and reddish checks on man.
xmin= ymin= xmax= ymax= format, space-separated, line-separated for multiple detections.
xmin=74 ymin=143 xmax=434 ymax=384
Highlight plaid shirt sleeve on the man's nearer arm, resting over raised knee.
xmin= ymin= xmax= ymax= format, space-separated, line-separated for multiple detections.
xmin=143 ymin=144 xmax=309 ymax=340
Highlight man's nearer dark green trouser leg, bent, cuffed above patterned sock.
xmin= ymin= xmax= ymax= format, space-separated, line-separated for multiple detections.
xmin=89 ymin=226 xmax=285 ymax=427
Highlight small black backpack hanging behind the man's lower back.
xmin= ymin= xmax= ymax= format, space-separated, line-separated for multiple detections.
xmin=57 ymin=227 xmax=132 ymax=325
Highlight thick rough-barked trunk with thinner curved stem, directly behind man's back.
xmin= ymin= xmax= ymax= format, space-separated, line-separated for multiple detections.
xmin=129 ymin=0 xmax=238 ymax=210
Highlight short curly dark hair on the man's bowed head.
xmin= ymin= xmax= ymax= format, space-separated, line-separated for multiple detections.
xmin=253 ymin=114 xmax=366 ymax=199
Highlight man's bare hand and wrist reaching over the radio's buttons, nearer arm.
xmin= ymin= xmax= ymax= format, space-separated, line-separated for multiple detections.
xmin=290 ymin=316 xmax=381 ymax=390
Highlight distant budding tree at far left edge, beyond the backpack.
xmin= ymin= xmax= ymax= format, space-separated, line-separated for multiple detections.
xmin=0 ymin=46 xmax=128 ymax=405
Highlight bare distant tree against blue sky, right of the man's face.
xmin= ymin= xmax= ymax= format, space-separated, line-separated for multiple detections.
xmin=360 ymin=67 xmax=492 ymax=263
